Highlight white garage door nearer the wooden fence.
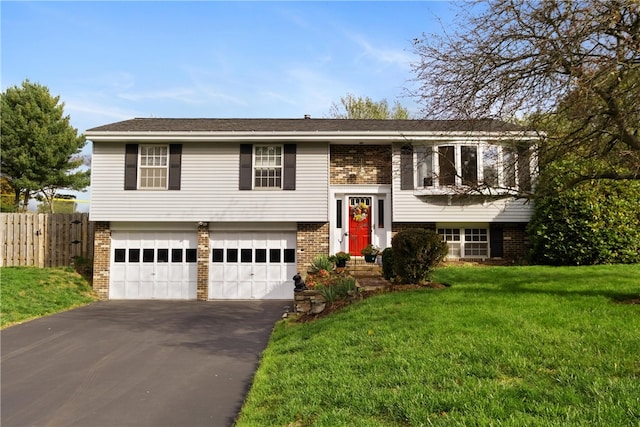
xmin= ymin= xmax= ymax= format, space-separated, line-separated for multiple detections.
xmin=109 ymin=231 xmax=197 ymax=299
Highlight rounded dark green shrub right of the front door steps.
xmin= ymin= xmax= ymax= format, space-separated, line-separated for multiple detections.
xmin=391 ymin=228 xmax=449 ymax=284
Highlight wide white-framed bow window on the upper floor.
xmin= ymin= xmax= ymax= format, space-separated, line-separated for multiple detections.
xmin=414 ymin=143 xmax=531 ymax=190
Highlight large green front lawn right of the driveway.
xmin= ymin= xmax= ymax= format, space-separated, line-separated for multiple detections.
xmin=237 ymin=265 xmax=640 ymax=427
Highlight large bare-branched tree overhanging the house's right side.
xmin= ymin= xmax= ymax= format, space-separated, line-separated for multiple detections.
xmin=414 ymin=0 xmax=640 ymax=181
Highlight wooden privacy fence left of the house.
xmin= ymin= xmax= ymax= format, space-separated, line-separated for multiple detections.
xmin=0 ymin=213 xmax=94 ymax=267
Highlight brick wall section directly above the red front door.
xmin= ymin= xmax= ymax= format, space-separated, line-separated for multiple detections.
xmin=330 ymin=145 xmax=391 ymax=185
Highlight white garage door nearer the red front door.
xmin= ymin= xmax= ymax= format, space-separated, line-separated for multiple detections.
xmin=209 ymin=231 xmax=297 ymax=299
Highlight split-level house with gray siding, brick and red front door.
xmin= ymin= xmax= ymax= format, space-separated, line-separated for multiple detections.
xmin=85 ymin=118 xmax=536 ymax=300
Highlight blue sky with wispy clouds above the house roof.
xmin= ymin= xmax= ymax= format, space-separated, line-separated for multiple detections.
xmin=0 ymin=1 xmax=454 ymax=209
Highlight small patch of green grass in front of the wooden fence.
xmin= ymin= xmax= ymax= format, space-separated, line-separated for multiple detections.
xmin=0 ymin=267 xmax=97 ymax=328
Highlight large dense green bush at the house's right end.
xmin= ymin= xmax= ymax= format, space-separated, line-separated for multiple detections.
xmin=528 ymin=181 xmax=640 ymax=265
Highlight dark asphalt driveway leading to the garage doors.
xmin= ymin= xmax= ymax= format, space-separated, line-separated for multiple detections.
xmin=0 ymin=301 xmax=290 ymax=427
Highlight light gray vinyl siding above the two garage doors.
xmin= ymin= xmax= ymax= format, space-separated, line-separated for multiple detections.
xmin=90 ymin=142 xmax=329 ymax=222
